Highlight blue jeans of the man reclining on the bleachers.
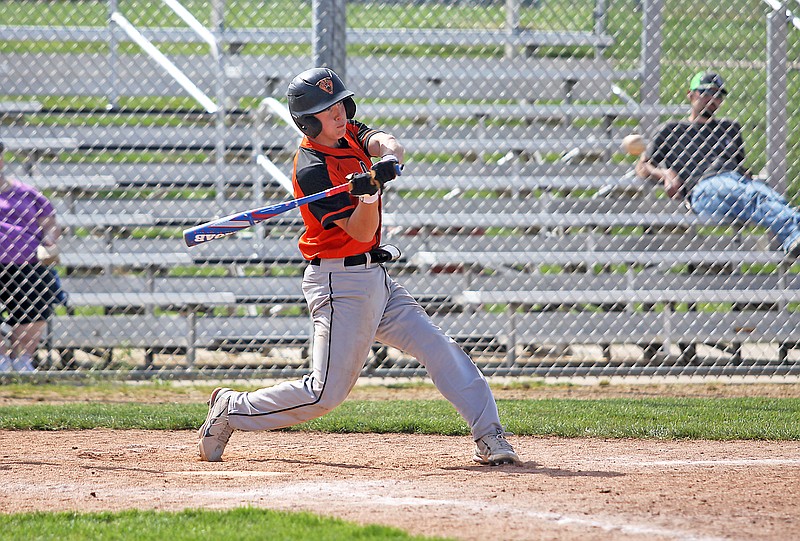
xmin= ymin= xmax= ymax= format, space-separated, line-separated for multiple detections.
xmin=691 ymin=171 xmax=800 ymax=252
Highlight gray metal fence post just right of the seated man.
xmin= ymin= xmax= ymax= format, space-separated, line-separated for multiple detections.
xmin=767 ymin=11 xmax=788 ymax=193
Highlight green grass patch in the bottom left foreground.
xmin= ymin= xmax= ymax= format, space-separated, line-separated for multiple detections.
xmin=0 ymin=508 xmax=450 ymax=541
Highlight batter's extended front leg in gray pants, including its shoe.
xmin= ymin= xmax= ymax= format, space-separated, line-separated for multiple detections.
xmin=376 ymin=275 xmax=519 ymax=463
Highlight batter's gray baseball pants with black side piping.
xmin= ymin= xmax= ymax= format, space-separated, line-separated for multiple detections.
xmin=228 ymin=259 xmax=501 ymax=440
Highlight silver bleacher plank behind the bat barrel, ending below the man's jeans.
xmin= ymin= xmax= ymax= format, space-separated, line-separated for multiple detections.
xmin=59 ymin=195 xmax=692 ymax=228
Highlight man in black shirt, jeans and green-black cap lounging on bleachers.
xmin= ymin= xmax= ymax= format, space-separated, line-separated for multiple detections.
xmin=636 ymin=72 xmax=800 ymax=257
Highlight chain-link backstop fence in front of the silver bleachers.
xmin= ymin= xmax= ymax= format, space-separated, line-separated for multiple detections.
xmin=0 ymin=0 xmax=800 ymax=377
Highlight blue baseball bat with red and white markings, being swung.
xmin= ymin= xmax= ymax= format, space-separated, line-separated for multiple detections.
xmin=183 ymin=166 xmax=400 ymax=247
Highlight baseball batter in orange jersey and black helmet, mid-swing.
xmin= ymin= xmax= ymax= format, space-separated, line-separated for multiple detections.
xmin=199 ymin=68 xmax=521 ymax=465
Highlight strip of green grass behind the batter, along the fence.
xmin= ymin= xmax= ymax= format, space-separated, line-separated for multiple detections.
xmin=0 ymin=397 xmax=800 ymax=440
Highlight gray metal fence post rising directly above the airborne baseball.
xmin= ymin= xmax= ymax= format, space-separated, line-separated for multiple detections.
xmin=639 ymin=0 xmax=664 ymax=139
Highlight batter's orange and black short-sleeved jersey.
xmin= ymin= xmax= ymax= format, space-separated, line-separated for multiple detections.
xmin=292 ymin=120 xmax=381 ymax=260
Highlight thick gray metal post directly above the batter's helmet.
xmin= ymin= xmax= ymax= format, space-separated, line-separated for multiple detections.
xmin=311 ymin=0 xmax=347 ymax=82
